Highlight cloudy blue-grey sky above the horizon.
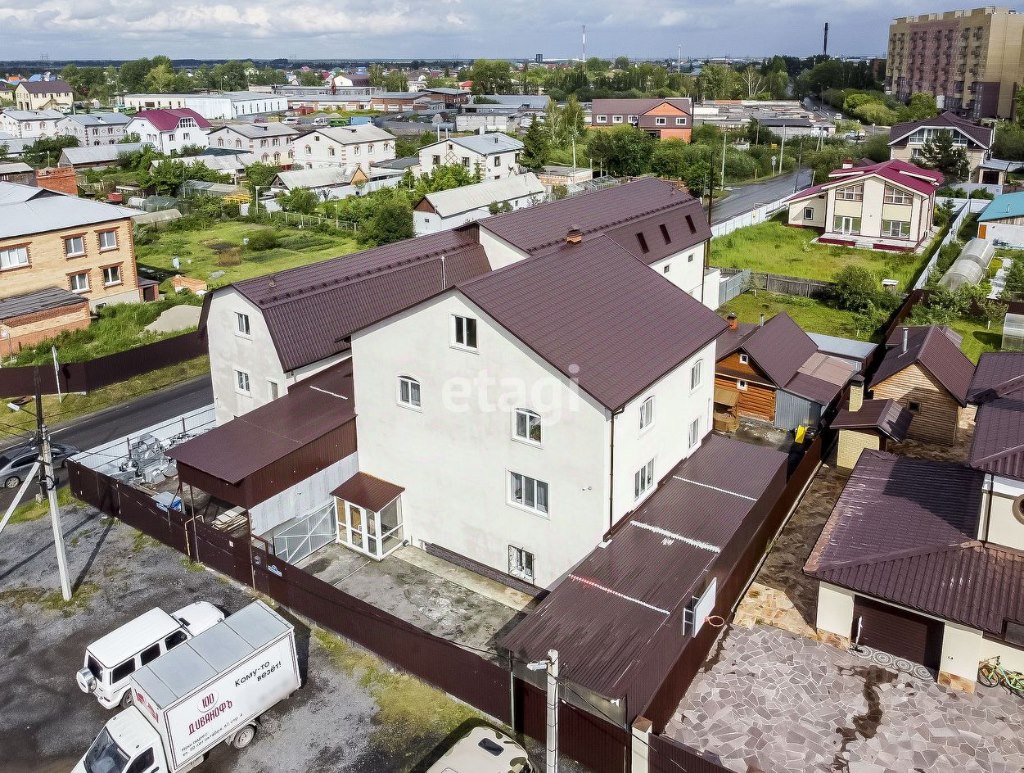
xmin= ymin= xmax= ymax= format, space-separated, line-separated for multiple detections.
xmin=0 ymin=0 xmax=941 ymax=60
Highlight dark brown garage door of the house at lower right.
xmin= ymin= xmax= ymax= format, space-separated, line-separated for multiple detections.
xmin=851 ymin=596 xmax=942 ymax=671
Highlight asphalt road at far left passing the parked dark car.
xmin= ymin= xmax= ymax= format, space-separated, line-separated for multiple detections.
xmin=0 ymin=376 xmax=213 ymax=515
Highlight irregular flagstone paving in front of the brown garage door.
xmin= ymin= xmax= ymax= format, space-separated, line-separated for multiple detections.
xmin=666 ymin=626 xmax=1024 ymax=773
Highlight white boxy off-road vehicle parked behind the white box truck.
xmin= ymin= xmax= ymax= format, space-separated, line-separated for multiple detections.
xmin=75 ymin=601 xmax=224 ymax=708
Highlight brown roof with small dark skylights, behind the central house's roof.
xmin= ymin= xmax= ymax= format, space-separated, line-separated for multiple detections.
xmin=480 ymin=178 xmax=711 ymax=263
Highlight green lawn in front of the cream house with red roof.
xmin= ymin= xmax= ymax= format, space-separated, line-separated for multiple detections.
xmin=711 ymin=220 xmax=924 ymax=289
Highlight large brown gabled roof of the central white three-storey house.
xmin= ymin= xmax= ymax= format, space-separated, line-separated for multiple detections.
xmin=459 ymin=234 xmax=725 ymax=411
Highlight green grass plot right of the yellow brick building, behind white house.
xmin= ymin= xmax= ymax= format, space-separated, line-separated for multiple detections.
xmin=135 ymin=221 xmax=361 ymax=289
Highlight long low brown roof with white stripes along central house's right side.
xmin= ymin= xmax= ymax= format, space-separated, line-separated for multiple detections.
xmin=502 ymin=435 xmax=786 ymax=711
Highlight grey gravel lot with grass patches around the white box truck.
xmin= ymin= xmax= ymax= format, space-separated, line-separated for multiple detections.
xmin=0 ymin=509 xmax=476 ymax=773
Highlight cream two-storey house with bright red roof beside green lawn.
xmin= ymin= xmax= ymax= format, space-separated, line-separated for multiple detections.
xmin=786 ymin=160 xmax=943 ymax=251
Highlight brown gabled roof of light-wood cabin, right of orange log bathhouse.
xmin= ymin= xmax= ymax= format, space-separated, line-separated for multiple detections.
xmin=870 ymin=326 xmax=974 ymax=405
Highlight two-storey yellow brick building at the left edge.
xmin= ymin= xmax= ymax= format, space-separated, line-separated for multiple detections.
xmin=0 ymin=182 xmax=141 ymax=349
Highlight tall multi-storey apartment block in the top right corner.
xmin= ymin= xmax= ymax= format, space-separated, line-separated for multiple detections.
xmin=886 ymin=6 xmax=1024 ymax=118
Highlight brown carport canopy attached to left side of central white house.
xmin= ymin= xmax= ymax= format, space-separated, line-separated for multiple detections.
xmin=167 ymin=360 xmax=355 ymax=509
